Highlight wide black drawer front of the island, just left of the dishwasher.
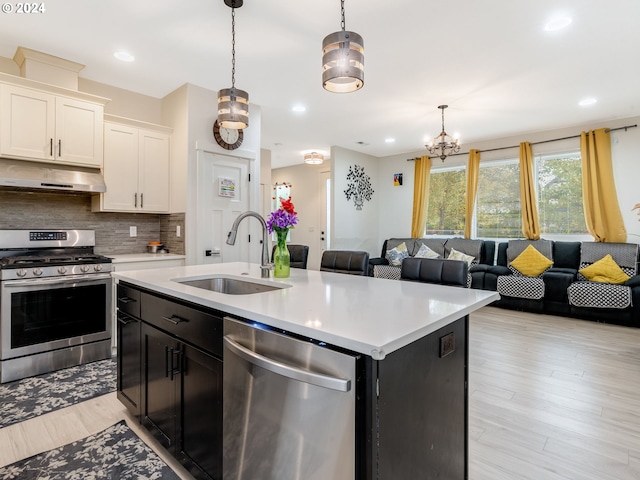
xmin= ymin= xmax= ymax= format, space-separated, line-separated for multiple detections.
xmin=140 ymin=292 xmax=222 ymax=358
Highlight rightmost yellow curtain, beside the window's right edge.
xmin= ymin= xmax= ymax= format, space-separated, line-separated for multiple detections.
xmin=580 ymin=128 xmax=627 ymax=242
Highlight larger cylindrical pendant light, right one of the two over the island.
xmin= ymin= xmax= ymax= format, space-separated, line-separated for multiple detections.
xmin=322 ymin=0 xmax=364 ymax=93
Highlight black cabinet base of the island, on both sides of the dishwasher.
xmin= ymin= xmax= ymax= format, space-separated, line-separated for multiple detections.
xmin=118 ymin=282 xmax=469 ymax=480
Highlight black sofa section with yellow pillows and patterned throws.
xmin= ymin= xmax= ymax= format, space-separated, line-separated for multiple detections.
xmin=474 ymin=240 xmax=640 ymax=326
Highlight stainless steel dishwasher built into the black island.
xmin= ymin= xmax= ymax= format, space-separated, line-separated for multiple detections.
xmin=223 ymin=317 xmax=356 ymax=480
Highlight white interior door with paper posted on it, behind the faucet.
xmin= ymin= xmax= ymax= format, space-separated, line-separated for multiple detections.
xmin=196 ymin=150 xmax=251 ymax=263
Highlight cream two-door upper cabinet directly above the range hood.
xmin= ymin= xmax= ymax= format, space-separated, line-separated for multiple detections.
xmin=0 ymin=84 xmax=104 ymax=168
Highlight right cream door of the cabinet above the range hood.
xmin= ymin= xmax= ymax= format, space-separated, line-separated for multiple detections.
xmin=55 ymin=97 xmax=104 ymax=168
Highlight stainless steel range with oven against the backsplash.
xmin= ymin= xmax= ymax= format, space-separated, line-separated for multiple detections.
xmin=0 ymin=230 xmax=113 ymax=383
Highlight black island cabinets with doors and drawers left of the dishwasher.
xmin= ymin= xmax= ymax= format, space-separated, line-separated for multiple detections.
xmin=118 ymin=285 xmax=222 ymax=480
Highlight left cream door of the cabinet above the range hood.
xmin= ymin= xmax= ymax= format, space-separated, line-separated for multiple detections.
xmin=0 ymin=85 xmax=56 ymax=161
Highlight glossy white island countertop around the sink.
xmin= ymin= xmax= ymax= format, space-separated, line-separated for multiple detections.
xmin=112 ymin=262 xmax=500 ymax=360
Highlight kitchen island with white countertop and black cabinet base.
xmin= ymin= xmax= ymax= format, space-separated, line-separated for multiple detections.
xmin=114 ymin=263 xmax=498 ymax=480
